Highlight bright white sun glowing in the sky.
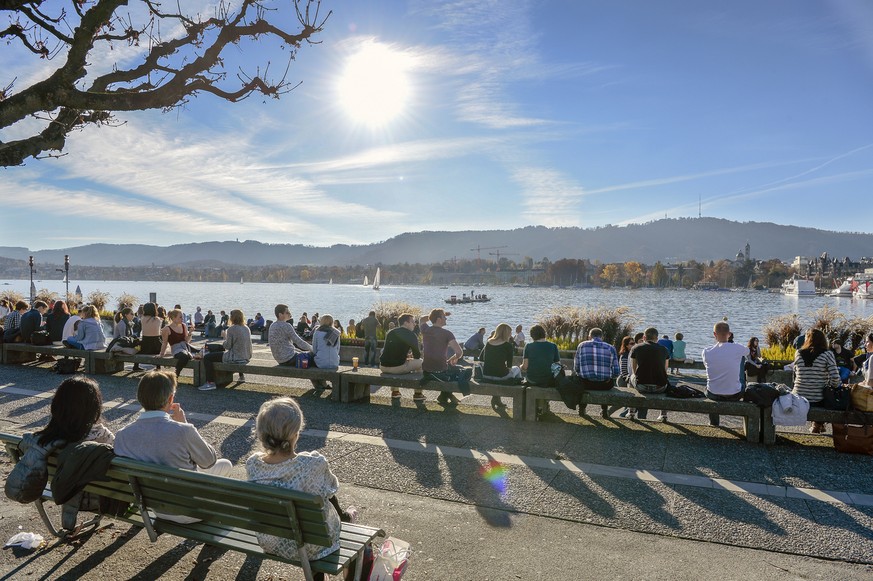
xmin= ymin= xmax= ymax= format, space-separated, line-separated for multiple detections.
xmin=338 ymin=42 xmax=411 ymax=127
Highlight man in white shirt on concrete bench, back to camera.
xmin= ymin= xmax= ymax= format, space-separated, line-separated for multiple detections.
xmin=703 ymin=321 xmax=749 ymax=426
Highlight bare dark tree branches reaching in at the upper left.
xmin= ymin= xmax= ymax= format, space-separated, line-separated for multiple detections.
xmin=0 ymin=0 xmax=330 ymax=167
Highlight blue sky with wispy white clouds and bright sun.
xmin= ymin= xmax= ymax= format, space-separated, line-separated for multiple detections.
xmin=0 ymin=0 xmax=873 ymax=250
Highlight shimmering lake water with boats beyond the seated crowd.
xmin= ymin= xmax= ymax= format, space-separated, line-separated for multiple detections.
xmin=0 ymin=280 xmax=873 ymax=358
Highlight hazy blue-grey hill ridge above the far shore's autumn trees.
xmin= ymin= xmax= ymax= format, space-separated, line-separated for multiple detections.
xmin=0 ymin=218 xmax=873 ymax=266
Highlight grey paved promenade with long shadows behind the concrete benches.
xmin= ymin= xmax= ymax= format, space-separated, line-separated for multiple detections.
xmin=0 ymin=358 xmax=873 ymax=580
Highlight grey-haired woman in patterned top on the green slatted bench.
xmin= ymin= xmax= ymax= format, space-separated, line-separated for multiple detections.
xmin=246 ymin=397 xmax=358 ymax=579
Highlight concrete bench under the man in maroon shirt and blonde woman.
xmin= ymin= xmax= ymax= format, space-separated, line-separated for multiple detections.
xmin=333 ymin=367 xmax=525 ymax=420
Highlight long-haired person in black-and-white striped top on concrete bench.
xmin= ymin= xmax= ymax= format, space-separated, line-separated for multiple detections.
xmin=793 ymin=329 xmax=840 ymax=434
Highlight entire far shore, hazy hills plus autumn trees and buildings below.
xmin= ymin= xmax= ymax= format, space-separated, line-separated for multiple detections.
xmin=0 ymin=218 xmax=873 ymax=289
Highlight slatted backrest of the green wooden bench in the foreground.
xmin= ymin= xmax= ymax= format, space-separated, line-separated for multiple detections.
xmin=0 ymin=433 xmax=332 ymax=547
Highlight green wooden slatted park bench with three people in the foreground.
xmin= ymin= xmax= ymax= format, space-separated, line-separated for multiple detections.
xmin=0 ymin=433 xmax=384 ymax=581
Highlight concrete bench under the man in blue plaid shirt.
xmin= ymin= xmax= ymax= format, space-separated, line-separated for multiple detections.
xmin=525 ymin=386 xmax=769 ymax=442
